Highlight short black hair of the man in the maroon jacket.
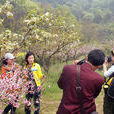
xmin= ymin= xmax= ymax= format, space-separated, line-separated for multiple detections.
xmin=88 ymin=49 xmax=105 ymax=66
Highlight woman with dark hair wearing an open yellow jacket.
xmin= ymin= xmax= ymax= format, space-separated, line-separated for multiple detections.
xmin=23 ymin=52 xmax=46 ymax=114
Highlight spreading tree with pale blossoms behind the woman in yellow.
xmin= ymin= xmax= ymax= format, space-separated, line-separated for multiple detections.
xmin=24 ymin=6 xmax=80 ymax=70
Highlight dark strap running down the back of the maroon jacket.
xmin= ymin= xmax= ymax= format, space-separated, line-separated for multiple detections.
xmin=76 ymin=65 xmax=84 ymax=114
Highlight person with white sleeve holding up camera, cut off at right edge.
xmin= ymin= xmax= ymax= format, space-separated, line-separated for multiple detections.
xmin=103 ymin=51 xmax=114 ymax=114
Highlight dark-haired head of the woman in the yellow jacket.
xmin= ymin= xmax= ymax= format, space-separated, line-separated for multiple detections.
xmin=25 ymin=52 xmax=35 ymax=65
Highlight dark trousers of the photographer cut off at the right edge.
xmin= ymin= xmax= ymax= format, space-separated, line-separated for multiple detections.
xmin=103 ymin=95 xmax=114 ymax=114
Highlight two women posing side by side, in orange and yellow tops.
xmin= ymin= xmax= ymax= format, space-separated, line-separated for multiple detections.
xmin=1 ymin=52 xmax=46 ymax=114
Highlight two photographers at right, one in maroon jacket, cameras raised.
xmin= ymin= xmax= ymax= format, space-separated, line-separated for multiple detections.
xmin=57 ymin=49 xmax=114 ymax=114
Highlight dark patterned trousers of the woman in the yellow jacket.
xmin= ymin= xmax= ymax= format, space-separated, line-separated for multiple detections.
xmin=25 ymin=91 xmax=41 ymax=114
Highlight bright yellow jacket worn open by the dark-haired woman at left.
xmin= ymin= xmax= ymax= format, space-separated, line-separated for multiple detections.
xmin=24 ymin=63 xmax=43 ymax=86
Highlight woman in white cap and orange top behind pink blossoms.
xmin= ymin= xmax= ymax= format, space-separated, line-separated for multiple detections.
xmin=1 ymin=53 xmax=19 ymax=114
